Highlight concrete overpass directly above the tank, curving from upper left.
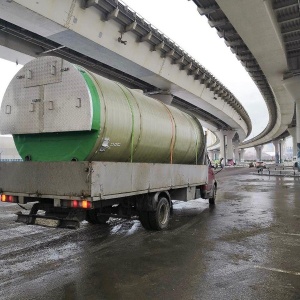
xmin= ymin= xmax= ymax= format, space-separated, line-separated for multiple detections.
xmin=0 ymin=0 xmax=252 ymax=158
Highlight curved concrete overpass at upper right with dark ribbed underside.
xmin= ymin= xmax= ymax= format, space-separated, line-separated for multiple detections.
xmin=194 ymin=0 xmax=300 ymax=164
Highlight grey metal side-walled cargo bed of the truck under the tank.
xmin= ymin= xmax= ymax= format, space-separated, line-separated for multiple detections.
xmin=0 ymin=161 xmax=208 ymax=201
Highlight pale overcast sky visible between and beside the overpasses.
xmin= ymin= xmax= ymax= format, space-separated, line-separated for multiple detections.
xmin=0 ymin=0 xmax=269 ymax=138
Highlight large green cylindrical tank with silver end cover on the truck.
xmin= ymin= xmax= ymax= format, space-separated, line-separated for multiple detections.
xmin=0 ymin=56 xmax=204 ymax=164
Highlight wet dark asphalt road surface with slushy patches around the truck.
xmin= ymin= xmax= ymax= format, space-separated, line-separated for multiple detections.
xmin=0 ymin=168 xmax=300 ymax=300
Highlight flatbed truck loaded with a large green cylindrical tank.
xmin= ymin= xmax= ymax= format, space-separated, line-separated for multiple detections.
xmin=0 ymin=56 xmax=217 ymax=230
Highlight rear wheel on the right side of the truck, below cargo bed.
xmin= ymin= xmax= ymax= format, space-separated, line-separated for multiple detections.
xmin=149 ymin=197 xmax=170 ymax=230
